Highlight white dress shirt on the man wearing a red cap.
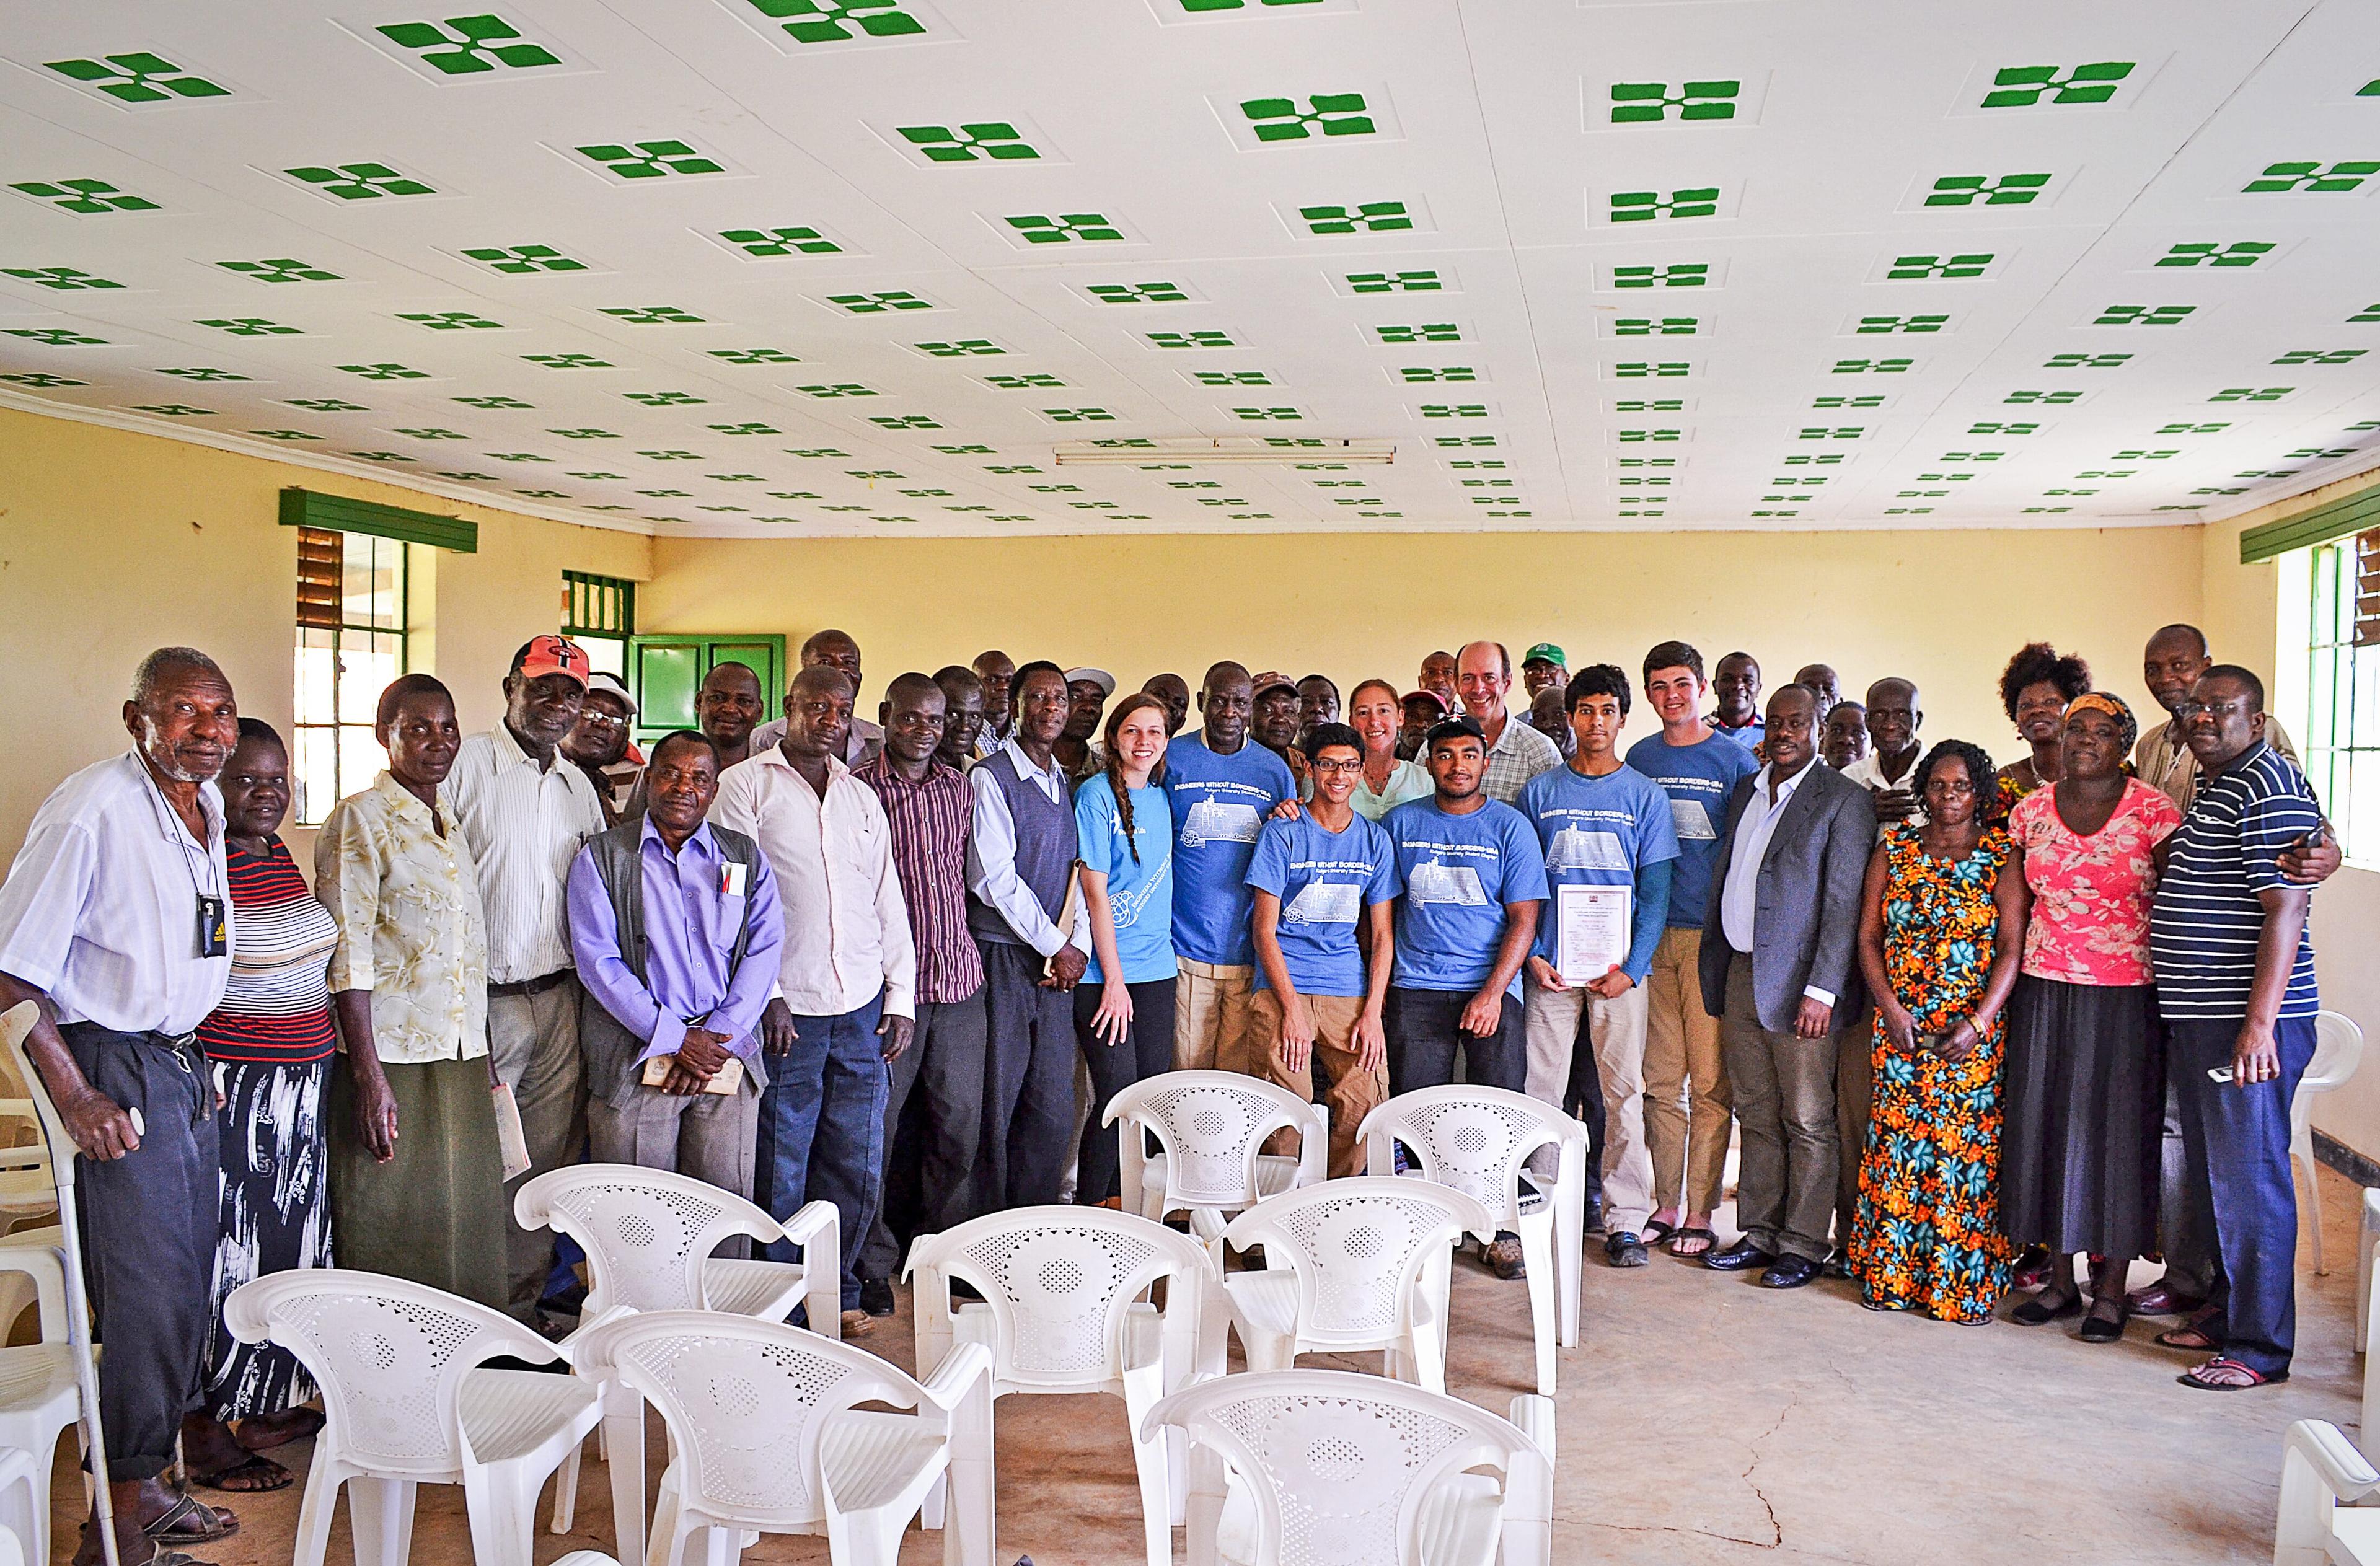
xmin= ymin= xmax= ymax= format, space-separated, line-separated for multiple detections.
xmin=445 ymin=723 xmax=604 ymax=985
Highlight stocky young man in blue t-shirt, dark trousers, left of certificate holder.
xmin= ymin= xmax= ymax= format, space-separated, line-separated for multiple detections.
xmin=1380 ymin=716 xmax=1545 ymax=1278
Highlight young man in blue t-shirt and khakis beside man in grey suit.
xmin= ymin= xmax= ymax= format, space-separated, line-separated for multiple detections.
xmin=1628 ymin=643 xmax=1761 ymax=1257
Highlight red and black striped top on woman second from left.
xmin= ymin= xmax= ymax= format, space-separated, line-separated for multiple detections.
xmin=198 ymin=838 xmax=338 ymax=1067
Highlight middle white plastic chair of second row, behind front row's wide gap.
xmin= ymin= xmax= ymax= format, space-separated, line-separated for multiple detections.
xmin=907 ymin=1207 xmax=1216 ymax=1566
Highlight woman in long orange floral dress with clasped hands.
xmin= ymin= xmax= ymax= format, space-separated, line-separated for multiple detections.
xmin=1849 ymin=740 xmax=2025 ymax=1326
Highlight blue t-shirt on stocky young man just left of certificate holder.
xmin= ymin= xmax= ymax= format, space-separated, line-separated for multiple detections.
xmin=1380 ymin=798 xmax=1545 ymax=995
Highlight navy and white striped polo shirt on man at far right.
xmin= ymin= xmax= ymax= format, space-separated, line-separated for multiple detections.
xmin=2149 ymin=742 xmax=2323 ymax=1021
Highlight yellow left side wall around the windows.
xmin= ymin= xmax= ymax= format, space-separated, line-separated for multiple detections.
xmin=0 ymin=410 xmax=652 ymax=852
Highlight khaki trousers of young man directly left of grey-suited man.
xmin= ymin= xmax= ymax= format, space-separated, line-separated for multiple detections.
xmin=1637 ymin=926 xmax=1735 ymax=1214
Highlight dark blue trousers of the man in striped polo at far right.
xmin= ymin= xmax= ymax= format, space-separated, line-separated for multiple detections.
xmin=2166 ymin=1016 xmax=2313 ymax=1376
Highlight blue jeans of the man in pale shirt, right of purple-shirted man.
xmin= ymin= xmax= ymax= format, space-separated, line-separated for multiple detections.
xmin=752 ymin=995 xmax=892 ymax=1311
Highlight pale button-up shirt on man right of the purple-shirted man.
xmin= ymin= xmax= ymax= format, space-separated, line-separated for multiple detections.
xmin=712 ymin=747 xmax=916 ymax=1019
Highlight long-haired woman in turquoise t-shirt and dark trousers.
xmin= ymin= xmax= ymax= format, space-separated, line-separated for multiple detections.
xmin=1073 ymin=693 xmax=1176 ymax=1207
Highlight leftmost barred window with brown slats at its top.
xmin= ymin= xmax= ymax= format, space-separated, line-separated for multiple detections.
xmin=290 ymin=529 xmax=407 ymax=826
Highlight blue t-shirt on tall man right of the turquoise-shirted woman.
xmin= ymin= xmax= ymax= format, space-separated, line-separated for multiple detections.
xmin=1166 ymin=733 xmax=1297 ymax=966
